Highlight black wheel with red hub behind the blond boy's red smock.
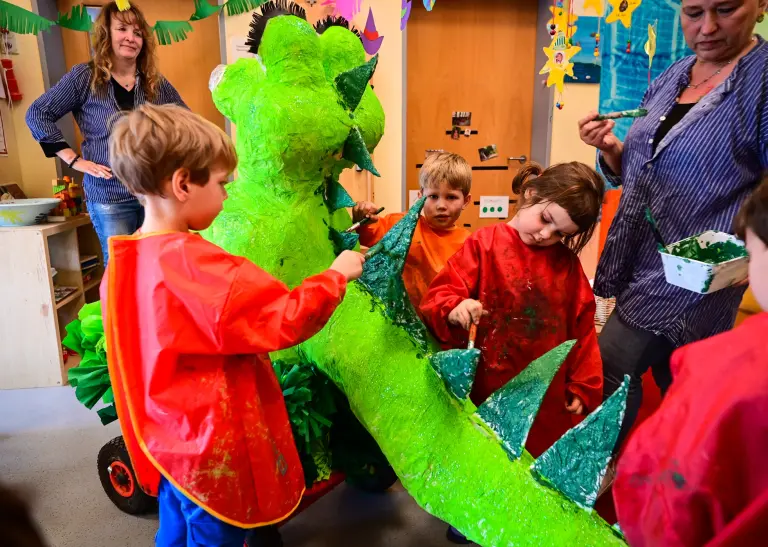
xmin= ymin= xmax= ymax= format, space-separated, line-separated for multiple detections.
xmin=96 ymin=436 xmax=157 ymax=515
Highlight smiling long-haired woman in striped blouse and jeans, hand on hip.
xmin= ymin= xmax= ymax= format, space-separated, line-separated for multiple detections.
xmin=27 ymin=2 xmax=186 ymax=264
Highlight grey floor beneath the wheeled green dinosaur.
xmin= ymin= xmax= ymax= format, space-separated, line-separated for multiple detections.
xmin=0 ymin=387 xmax=450 ymax=547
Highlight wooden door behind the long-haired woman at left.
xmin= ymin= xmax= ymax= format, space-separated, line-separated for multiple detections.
xmin=56 ymin=0 xmax=224 ymax=141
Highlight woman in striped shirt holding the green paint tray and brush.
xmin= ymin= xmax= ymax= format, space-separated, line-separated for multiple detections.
xmin=579 ymin=0 xmax=768 ymax=454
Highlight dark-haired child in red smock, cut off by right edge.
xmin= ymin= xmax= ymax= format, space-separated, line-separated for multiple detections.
xmin=613 ymin=179 xmax=768 ymax=547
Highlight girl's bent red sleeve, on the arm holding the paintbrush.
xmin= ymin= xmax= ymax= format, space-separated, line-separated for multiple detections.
xmin=419 ymin=237 xmax=480 ymax=347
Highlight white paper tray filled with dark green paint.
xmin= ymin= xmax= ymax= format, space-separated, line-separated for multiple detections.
xmin=659 ymin=230 xmax=749 ymax=294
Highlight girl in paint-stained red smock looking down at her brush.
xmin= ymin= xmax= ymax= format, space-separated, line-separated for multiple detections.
xmin=421 ymin=162 xmax=604 ymax=456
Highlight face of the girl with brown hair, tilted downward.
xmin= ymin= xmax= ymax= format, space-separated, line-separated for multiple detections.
xmin=510 ymin=194 xmax=579 ymax=247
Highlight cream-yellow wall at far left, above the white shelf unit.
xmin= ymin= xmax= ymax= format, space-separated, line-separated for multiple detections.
xmin=0 ymin=0 xmax=57 ymax=197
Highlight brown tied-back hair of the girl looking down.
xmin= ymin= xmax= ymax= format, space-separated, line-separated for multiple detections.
xmin=512 ymin=161 xmax=605 ymax=254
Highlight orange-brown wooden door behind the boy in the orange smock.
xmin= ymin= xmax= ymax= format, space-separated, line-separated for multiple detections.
xmin=406 ymin=0 xmax=538 ymax=230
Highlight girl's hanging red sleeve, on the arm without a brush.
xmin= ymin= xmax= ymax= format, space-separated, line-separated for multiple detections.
xmin=565 ymin=264 xmax=603 ymax=412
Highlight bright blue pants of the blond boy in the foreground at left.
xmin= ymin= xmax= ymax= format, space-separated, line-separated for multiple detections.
xmin=155 ymin=478 xmax=248 ymax=547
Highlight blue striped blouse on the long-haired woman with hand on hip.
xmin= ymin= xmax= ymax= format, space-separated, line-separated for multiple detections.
xmin=26 ymin=64 xmax=186 ymax=203
